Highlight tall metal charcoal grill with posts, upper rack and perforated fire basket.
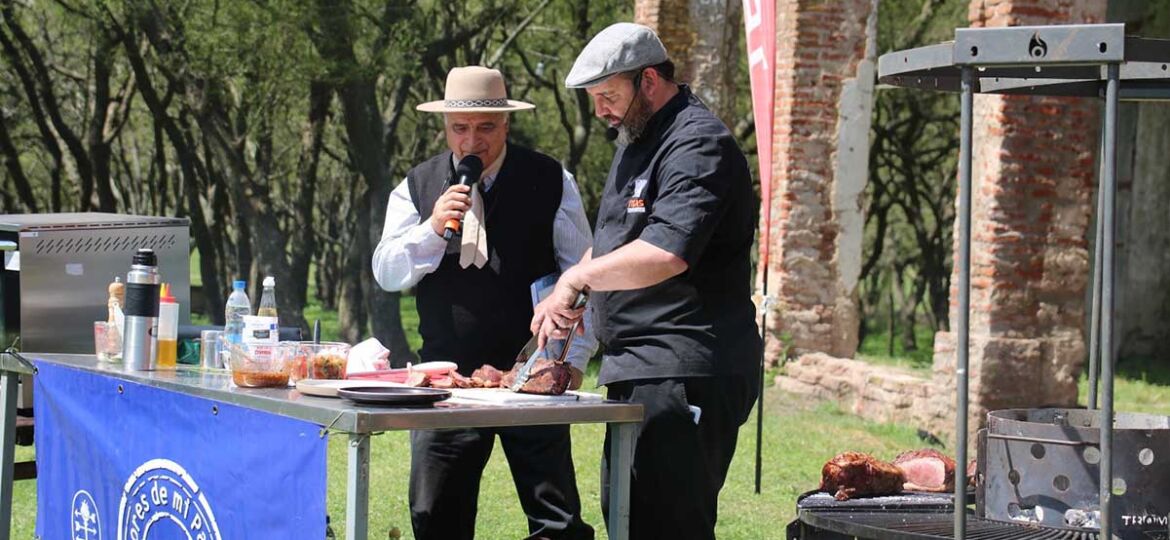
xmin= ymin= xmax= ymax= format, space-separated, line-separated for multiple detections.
xmin=789 ymin=25 xmax=1170 ymax=540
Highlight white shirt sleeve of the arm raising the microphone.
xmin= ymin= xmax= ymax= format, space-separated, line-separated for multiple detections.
xmin=373 ymin=179 xmax=447 ymax=291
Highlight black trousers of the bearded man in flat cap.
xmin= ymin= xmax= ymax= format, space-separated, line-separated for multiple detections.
xmin=601 ymin=375 xmax=759 ymax=540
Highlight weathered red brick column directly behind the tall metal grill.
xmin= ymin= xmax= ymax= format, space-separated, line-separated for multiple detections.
xmin=932 ymin=0 xmax=1106 ymax=432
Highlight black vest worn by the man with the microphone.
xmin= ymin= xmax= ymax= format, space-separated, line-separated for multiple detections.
xmin=406 ymin=144 xmax=564 ymax=375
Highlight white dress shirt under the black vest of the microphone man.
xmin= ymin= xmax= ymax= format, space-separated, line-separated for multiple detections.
xmin=373 ymin=156 xmax=597 ymax=372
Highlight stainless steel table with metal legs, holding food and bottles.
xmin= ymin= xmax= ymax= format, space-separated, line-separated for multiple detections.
xmin=0 ymin=353 xmax=642 ymax=540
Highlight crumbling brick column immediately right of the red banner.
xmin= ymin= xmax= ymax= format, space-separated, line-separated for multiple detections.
xmin=757 ymin=0 xmax=873 ymax=359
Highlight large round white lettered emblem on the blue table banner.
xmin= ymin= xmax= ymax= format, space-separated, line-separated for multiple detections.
xmin=118 ymin=459 xmax=222 ymax=540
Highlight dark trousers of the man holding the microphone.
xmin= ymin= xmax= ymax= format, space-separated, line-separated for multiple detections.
xmin=411 ymin=425 xmax=593 ymax=540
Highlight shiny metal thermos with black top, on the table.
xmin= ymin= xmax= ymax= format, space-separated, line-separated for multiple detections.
xmin=122 ymin=249 xmax=159 ymax=371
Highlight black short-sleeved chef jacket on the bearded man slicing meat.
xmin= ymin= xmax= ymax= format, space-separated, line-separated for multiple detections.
xmin=591 ymin=85 xmax=762 ymax=385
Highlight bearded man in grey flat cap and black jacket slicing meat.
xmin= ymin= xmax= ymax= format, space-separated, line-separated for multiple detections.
xmin=532 ymin=23 xmax=762 ymax=539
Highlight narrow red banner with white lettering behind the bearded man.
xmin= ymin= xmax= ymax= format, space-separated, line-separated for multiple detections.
xmin=743 ymin=0 xmax=776 ymax=291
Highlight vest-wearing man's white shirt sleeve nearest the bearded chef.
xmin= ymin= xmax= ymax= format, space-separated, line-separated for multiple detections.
xmin=552 ymin=171 xmax=597 ymax=373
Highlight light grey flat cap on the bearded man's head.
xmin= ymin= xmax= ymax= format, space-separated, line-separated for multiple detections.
xmin=565 ymin=22 xmax=667 ymax=88
